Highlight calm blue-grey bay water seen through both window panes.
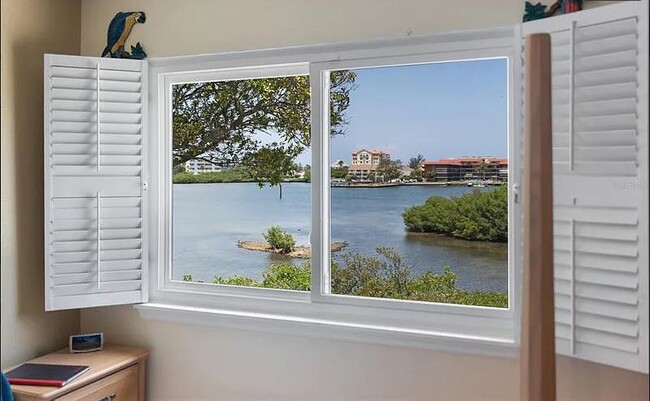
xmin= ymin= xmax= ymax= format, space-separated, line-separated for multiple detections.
xmin=172 ymin=183 xmax=508 ymax=291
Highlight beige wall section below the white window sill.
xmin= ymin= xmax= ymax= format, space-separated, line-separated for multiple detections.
xmin=82 ymin=306 xmax=648 ymax=401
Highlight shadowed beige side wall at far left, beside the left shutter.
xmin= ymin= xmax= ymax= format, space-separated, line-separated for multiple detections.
xmin=0 ymin=0 xmax=81 ymax=367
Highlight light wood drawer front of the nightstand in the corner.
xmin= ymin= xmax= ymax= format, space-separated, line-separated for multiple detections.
xmin=56 ymin=365 xmax=138 ymax=401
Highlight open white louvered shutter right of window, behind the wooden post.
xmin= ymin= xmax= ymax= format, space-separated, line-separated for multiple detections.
xmin=523 ymin=2 xmax=648 ymax=373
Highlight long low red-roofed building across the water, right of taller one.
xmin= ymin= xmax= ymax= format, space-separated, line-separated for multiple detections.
xmin=422 ymin=156 xmax=508 ymax=182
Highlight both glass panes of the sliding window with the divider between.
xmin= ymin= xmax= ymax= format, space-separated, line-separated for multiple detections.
xmin=164 ymin=51 xmax=514 ymax=313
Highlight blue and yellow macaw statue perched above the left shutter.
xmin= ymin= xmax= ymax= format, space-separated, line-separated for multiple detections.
xmin=102 ymin=11 xmax=147 ymax=59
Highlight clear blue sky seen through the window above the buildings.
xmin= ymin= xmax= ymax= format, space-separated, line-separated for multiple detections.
xmin=256 ymin=59 xmax=508 ymax=165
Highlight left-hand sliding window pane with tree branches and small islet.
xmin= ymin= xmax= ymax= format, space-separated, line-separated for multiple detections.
xmin=171 ymin=76 xmax=311 ymax=291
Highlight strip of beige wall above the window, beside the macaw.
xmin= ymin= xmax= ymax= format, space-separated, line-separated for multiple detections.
xmin=81 ymin=0 xmax=613 ymax=57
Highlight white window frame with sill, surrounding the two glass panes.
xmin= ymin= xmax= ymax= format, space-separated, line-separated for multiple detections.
xmin=136 ymin=27 xmax=521 ymax=355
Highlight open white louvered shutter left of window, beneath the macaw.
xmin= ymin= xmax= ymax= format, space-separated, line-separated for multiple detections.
xmin=44 ymin=55 xmax=147 ymax=310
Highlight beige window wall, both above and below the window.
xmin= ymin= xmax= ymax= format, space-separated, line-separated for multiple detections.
xmin=81 ymin=0 xmax=648 ymax=401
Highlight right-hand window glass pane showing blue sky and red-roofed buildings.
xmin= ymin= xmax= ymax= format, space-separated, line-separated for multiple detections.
xmin=329 ymin=59 xmax=508 ymax=308
